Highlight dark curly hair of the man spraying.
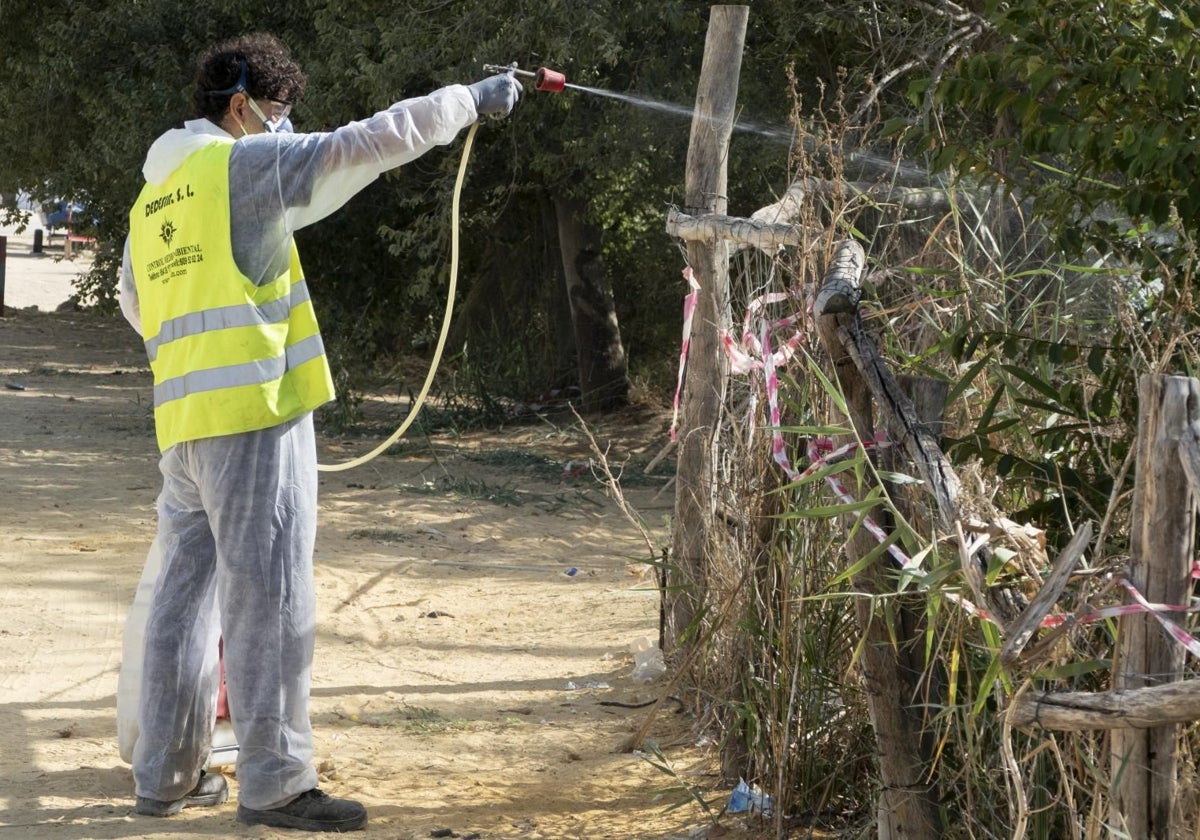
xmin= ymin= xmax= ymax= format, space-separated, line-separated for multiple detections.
xmin=192 ymin=32 xmax=308 ymax=122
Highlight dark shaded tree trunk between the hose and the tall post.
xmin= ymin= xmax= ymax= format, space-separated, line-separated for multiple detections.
xmin=554 ymin=198 xmax=629 ymax=413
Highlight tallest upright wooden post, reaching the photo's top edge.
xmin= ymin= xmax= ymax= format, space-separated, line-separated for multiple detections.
xmin=662 ymin=6 xmax=750 ymax=650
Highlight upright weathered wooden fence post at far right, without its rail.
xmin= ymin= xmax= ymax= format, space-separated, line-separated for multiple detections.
xmin=1109 ymin=374 xmax=1200 ymax=840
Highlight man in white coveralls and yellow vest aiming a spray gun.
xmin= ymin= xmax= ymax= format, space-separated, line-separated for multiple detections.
xmin=120 ymin=34 xmax=521 ymax=832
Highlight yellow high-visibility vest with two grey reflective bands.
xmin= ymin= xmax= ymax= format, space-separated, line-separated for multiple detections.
xmin=130 ymin=140 xmax=334 ymax=451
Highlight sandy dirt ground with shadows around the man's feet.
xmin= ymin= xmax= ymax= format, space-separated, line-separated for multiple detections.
xmin=0 ymin=238 xmax=757 ymax=840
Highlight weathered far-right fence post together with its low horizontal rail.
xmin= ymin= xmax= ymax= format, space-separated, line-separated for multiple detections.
xmin=1008 ymin=374 xmax=1200 ymax=840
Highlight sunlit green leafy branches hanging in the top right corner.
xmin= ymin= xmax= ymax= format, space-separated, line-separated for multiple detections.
xmin=916 ymin=0 xmax=1200 ymax=248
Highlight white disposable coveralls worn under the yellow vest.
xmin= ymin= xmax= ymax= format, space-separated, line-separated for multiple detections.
xmin=120 ymin=85 xmax=478 ymax=810
